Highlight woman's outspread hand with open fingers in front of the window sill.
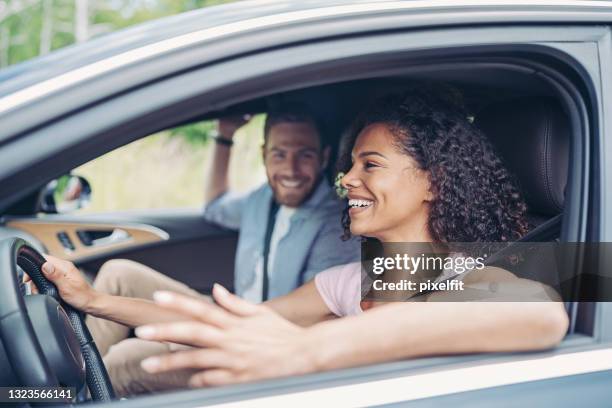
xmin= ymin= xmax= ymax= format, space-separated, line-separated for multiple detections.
xmin=136 ymin=285 xmax=315 ymax=387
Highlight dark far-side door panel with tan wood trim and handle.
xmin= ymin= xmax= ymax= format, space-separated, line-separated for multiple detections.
xmin=5 ymin=210 xmax=237 ymax=292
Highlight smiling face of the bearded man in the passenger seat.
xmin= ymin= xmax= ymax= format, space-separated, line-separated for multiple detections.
xmin=263 ymin=122 xmax=329 ymax=207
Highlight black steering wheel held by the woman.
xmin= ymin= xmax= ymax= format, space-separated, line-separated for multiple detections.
xmin=0 ymin=238 xmax=115 ymax=401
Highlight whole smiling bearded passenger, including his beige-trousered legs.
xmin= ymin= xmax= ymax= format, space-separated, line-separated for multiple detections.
xmin=87 ymin=105 xmax=360 ymax=396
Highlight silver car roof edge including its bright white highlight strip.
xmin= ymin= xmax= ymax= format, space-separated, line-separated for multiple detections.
xmin=0 ymin=0 xmax=612 ymax=114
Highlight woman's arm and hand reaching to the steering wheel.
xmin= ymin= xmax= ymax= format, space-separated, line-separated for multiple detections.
xmin=26 ymin=255 xmax=185 ymax=327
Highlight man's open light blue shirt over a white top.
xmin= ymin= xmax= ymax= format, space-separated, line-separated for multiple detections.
xmin=204 ymin=181 xmax=360 ymax=298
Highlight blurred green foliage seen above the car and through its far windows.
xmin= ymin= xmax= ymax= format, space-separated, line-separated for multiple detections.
xmin=0 ymin=0 xmax=265 ymax=212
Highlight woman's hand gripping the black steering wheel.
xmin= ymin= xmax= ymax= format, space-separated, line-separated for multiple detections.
xmin=23 ymin=255 xmax=98 ymax=312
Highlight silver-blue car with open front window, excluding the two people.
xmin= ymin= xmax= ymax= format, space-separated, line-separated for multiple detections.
xmin=0 ymin=0 xmax=612 ymax=408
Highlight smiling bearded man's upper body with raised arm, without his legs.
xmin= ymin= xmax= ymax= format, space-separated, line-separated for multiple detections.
xmin=204 ymin=104 xmax=359 ymax=302
